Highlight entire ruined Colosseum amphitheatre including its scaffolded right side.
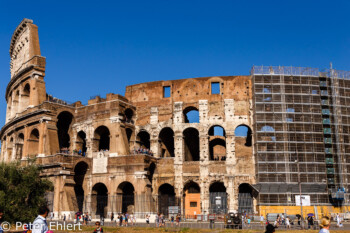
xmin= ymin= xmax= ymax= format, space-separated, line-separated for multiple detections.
xmin=0 ymin=19 xmax=350 ymax=219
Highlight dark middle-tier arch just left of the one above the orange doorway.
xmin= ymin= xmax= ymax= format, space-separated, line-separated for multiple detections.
xmin=159 ymin=127 xmax=175 ymax=157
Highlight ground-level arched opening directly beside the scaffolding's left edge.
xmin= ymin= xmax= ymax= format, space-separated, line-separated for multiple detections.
xmin=238 ymin=183 xmax=254 ymax=213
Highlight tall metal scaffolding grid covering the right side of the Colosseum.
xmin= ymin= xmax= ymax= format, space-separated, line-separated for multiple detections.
xmin=251 ymin=66 xmax=350 ymax=205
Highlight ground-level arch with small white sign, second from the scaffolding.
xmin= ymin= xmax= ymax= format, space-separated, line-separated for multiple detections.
xmin=209 ymin=182 xmax=228 ymax=214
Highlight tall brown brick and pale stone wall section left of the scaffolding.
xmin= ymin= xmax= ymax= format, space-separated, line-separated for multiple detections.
xmin=125 ymin=76 xmax=255 ymax=211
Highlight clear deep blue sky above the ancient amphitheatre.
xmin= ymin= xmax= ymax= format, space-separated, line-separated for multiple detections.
xmin=0 ymin=0 xmax=350 ymax=132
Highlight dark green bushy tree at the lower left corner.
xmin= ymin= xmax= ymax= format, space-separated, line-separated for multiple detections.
xmin=0 ymin=161 xmax=53 ymax=223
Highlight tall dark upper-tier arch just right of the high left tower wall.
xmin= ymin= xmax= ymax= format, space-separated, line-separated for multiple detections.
xmin=57 ymin=112 xmax=73 ymax=153
